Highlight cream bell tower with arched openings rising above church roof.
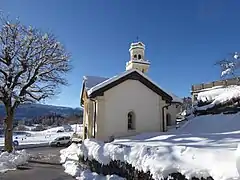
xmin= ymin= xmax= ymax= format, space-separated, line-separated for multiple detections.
xmin=126 ymin=41 xmax=150 ymax=73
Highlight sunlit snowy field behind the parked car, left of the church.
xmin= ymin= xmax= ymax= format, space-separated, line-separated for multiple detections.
xmin=0 ymin=124 xmax=82 ymax=146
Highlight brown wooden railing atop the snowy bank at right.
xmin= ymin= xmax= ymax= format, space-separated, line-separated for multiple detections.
xmin=191 ymin=77 xmax=240 ymax=103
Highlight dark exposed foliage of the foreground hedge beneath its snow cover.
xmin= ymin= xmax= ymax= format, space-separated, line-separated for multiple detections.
xmin=79 ymin=157 xmax=214 ymax=180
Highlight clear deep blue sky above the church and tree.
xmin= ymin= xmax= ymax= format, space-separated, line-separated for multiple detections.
xmin=0 ymin=0 xmax=240 ymax=107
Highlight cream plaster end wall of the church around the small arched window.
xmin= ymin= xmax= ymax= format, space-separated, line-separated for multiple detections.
xmin=94 ymin=80 xmax=165 ymax=140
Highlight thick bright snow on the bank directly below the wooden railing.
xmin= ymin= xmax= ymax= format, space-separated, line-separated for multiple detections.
xmin=197 ymin=85 xmax=240 ymax=110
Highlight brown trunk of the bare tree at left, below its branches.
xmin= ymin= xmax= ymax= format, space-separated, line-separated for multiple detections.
xmin=4 ymin=107 xmax=14 ymax=152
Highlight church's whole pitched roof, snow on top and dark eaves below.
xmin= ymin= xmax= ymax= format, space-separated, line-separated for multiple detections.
xmin=80 ymin=69 xmax=182 ymax=105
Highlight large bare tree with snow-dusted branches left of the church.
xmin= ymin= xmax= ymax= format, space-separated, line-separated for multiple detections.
xmin=0 ymin=14 xmax=70 ymax=152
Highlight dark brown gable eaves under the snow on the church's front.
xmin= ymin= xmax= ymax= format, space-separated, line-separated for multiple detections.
xmin=90 ymin=71 xmax=172 ymax=102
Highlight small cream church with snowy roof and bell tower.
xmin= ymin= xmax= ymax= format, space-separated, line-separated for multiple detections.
xmin=80 ymin=42 xmax=182 ymax=141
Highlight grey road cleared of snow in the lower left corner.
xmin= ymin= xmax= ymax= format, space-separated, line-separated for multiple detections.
xmin=0 ymin=147 xmax=74 ymax=180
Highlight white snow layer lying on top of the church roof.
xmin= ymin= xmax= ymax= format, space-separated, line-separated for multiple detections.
xmin=81 ymin=69 xmax=183 ymax=103
